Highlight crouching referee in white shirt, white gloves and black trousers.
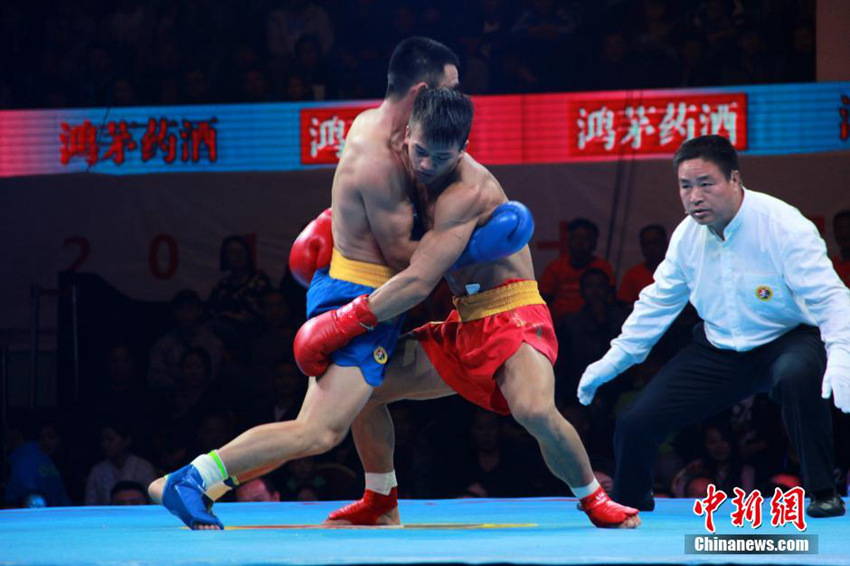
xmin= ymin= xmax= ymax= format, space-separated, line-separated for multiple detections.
xmin=578 ymin=136 xmax=850 ymax=517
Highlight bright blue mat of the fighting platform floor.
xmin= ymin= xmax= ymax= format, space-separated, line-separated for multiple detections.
xmin=0 ymin=498 xmax=850 ymax=566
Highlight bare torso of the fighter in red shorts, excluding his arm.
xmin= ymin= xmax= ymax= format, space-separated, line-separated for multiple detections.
xmin=419 ymin=153 xmax=534 ymax=296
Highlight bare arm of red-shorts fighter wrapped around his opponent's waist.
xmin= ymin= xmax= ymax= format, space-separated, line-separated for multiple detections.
xmin=369 ymin=184 xmax=486 ymax=321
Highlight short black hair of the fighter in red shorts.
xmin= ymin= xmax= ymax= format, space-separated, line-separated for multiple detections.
xmin=409 ymin=88 xmax=475 ymax=148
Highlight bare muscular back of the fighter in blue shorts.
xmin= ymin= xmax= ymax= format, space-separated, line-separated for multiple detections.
xmin=332 ymin=108 xmax=416 ymax=270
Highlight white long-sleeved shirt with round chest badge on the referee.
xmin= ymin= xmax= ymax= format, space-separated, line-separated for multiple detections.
xmin=603 ymin=190 xmax=850 ymax=373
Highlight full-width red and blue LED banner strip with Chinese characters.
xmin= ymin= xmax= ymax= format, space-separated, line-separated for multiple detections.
xmin=0 ymin=82 xmax=850 ymax=177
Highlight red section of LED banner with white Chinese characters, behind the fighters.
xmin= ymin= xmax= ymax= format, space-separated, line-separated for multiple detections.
xmin=301 ymin=91 xmax=747 ymax=165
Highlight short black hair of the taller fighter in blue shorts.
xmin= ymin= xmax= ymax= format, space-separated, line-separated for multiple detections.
xmin=386 ymin=37 xmax=459 ymax=98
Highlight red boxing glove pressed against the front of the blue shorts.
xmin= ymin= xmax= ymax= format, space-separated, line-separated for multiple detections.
xmin=292 ymin=295 xmax=378 ymax=377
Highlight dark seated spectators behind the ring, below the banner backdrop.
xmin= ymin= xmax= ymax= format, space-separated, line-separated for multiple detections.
xmin=0 ymin=210 xmax=850 ymax=507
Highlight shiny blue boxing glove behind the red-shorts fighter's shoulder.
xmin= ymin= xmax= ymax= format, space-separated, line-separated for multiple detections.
xmin=452 ymin=200 xmax=534 ymax=269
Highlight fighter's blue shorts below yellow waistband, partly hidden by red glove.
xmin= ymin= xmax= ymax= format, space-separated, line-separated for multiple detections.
xmin=307 ymin=268 xmax=404 ymax=387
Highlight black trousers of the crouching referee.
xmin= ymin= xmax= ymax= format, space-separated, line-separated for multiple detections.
xmin=613 ymin=323 xmax=834 ymax=505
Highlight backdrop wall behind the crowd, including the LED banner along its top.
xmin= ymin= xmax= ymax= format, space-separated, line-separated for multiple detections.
xmin=0 ymin=83 xmax=850 ymax=340
